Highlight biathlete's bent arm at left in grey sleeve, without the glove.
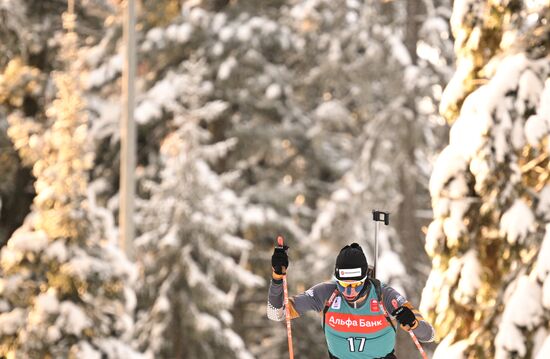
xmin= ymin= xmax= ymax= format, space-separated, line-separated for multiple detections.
xmin=267 ymin=279 xmax=336 ymax=321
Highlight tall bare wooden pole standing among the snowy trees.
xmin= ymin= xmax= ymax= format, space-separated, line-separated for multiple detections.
xmin=119 ymin=0 xmax=136 ymax=258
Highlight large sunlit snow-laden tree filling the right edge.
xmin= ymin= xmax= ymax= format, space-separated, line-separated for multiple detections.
xmin=422 ymin=1 xmax=550 ymax=359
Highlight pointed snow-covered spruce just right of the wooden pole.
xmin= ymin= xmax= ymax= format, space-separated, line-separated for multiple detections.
xmin=133 ymin=57 xmax=263 ymax=359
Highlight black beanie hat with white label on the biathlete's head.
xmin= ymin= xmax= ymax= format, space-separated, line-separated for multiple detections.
xmin=334 ymin=243 xmax=369 ymax=280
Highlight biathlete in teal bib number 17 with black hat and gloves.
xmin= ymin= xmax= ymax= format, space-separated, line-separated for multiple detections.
xmin=267 ymin=243 xmax=435 ymax=359
